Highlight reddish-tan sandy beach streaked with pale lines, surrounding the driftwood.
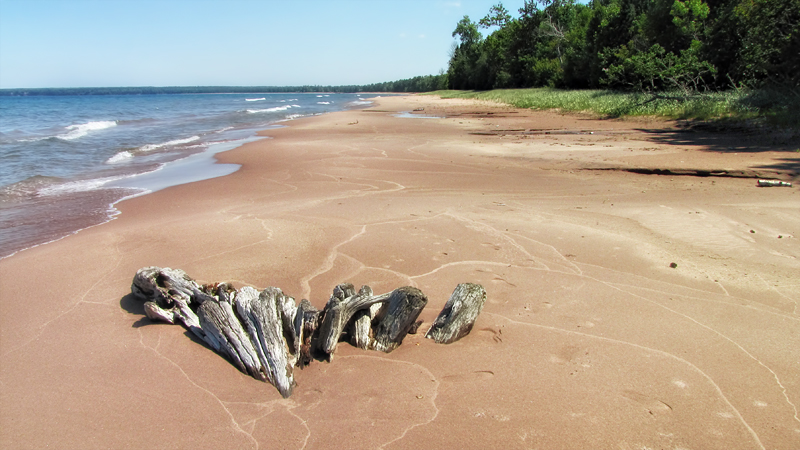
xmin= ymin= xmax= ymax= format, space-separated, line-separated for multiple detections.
xmin=0 ymin=96 xmax=800 ymax=450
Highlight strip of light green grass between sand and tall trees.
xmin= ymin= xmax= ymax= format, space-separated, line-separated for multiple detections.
xmin=430 ymin=88 xmax=800 ymax=130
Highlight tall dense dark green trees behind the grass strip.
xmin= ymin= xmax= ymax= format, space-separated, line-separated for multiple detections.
xmin=447 ymin=0 xmax=800 ymax=95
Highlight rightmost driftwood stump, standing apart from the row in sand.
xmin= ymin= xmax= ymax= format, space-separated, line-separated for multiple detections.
xmin=425 ymin=283 xmax=486 ymax=344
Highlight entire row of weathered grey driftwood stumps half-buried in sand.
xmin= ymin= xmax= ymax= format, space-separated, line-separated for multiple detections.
xmin=131 ymin=267 xmax=486 ymax=398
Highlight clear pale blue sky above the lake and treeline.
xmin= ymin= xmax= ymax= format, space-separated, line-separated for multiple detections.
xmin=0 ymin=0 xmax=536 ymax=89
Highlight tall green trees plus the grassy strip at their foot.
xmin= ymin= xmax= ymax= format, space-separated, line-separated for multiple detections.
xmin=437 ymin=0 xmax=800 ymax=128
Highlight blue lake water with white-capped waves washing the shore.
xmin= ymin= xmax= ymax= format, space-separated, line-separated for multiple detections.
xmin=0 ymin=93 xmax=370 ymax=258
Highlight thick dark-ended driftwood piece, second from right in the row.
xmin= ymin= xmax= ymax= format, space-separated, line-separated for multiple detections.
xmin=370 ymin=286 xmax=428 ymax=353
